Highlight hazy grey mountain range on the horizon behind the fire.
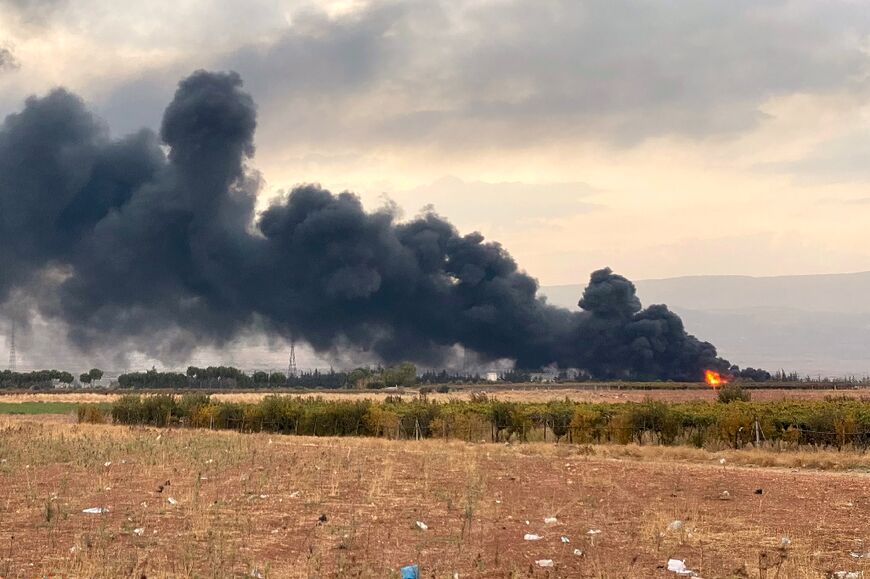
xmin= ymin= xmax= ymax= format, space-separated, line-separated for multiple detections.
xmin=541 ymin=272 xmax=870 ymax=376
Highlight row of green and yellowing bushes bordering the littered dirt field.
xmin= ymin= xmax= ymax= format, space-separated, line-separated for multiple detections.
xmin=78 ymin=391 xmax=870 ymax=448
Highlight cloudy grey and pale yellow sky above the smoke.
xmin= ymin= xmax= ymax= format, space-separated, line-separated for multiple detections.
xmin=0 ymin=0 xmax=870 ymax=285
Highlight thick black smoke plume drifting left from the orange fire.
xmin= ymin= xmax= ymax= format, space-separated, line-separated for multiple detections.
xmin=0 ymin=71 xmax=727 ymax=379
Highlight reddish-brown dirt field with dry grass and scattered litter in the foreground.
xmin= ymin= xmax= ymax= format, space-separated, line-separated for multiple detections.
xmin=0 ymin=417 xmax=870 ymax=579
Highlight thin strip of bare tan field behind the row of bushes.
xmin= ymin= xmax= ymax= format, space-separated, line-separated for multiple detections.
xmin=0 ymin=387 xmax=870 ymax=403
